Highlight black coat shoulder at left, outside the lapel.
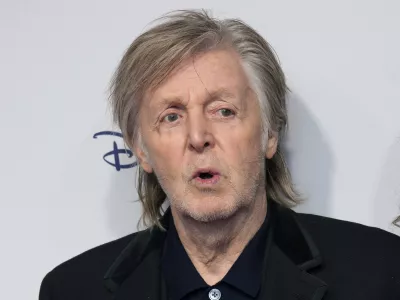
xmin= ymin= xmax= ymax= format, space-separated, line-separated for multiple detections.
xmin=39 ymin=233 xmax=137 ymax=300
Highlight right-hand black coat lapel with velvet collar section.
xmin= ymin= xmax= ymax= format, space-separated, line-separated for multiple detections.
xmin=258 ymin=203 xmax=327 ymax=300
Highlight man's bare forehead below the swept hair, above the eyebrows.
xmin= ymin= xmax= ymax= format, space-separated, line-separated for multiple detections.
xmin=149 ymin=49 xmax=248 ymax=106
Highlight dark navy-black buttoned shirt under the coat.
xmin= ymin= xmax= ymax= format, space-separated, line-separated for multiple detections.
xmin=161 ymin=209 xmax=269 ymax=300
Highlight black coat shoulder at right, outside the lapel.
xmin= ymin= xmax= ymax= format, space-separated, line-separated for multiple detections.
xmin=297 ymin=214 xmax=400 ymax=299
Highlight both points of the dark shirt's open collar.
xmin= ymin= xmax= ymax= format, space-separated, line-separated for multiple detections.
xmin=161 ymin=204 xmax=269 ymax=300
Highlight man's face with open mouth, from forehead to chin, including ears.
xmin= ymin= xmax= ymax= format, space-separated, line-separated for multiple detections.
xmin=136 ymin=50 xmax=275 ymax=222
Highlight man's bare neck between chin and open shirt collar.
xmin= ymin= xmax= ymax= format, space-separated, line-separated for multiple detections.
xmin=172 ymin=193 xmax=267 ymax=285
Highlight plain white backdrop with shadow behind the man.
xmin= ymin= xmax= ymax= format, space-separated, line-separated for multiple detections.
xmin=0 ymin=0 xmax=400 ymax=299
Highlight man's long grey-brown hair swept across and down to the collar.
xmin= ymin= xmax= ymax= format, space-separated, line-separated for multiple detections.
xmin=110 ymin=10 xmax=301 ymax=230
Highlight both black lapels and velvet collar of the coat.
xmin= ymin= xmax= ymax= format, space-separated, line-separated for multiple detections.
xmin=104 ymin=201 xmax=327 ymax=300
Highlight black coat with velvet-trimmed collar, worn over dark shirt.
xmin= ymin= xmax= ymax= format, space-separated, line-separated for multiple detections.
xmin=39 ymin=204 xmax=400 ymax=300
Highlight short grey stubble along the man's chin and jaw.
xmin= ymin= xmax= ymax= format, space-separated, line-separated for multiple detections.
xmin=155 ymin=151 xmax=263 ymax=224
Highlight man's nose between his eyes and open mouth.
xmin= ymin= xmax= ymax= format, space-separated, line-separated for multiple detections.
xmin=188 ymin=112 xmax=214 ymax=153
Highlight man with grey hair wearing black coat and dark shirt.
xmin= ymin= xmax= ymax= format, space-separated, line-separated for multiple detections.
xmin=39 ymin=11 xmax=400 ymax=300
